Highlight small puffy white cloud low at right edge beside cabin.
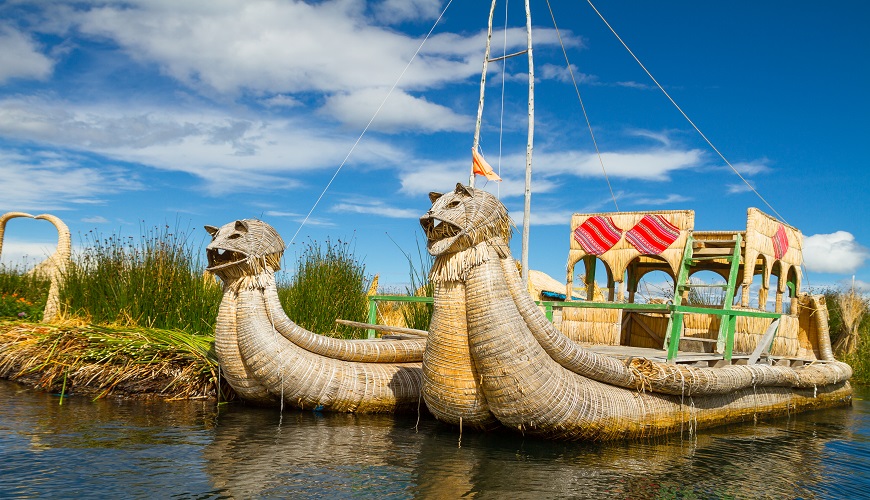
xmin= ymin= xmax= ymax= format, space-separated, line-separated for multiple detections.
xmin=803 ymin=231 xmax=870 ymax=274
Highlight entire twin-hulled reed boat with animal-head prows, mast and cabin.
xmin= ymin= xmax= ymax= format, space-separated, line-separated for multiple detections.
xmin=207 ymin=0 xmax=852 ymax=440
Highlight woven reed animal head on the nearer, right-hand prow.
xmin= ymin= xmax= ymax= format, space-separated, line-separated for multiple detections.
xmin=420 ymin=184 xmax=513 ymax=256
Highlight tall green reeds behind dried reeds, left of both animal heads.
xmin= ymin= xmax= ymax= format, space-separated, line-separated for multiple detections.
xmin=60 ymin=225 xmax=221 ymax=334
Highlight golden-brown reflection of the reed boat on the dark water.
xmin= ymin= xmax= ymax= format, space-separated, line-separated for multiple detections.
xmin=204 ymin=402 xmax=870 ymax=498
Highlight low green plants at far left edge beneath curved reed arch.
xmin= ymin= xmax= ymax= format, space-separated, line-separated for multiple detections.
xmin=0 ymin=264 xmax=51 ymax=321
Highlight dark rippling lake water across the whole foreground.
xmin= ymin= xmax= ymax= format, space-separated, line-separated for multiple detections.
xmin=0 ymin=380 xmax=870 ymax=498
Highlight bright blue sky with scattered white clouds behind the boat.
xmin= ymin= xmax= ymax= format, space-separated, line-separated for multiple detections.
xmin=0 ymin=0 xmax=870 ymax=287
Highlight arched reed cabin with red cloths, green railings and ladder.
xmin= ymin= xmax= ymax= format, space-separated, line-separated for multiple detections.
xmin=556 ymin=208 xmax=833 ymax=366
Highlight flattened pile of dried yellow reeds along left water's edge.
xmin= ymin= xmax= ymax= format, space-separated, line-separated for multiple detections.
xmin=0 ymin=321 xmax=225 ymax=399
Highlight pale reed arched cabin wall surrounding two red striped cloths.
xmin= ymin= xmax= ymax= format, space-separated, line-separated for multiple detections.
xmin=566 ymin=210 xmax=695 ymax=293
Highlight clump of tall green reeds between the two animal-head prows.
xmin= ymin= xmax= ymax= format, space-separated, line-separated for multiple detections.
xmin=278 ymin=238 xmax=371 ymax=338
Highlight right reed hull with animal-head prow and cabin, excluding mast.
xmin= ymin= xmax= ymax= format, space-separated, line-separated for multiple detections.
xmin=420 ymin=185 xmax=852 ymax=440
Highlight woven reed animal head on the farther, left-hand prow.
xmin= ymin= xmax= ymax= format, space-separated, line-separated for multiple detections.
xmin=205 ymin=219 xmax=284 ymax=281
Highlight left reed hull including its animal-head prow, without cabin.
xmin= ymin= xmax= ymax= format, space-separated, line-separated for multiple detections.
xmin=207 ymin=220 xmax=426 ymax=413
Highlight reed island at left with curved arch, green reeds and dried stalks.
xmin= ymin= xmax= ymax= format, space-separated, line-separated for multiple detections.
xmin=0 ymin=212 xmax=225 ymax=400
